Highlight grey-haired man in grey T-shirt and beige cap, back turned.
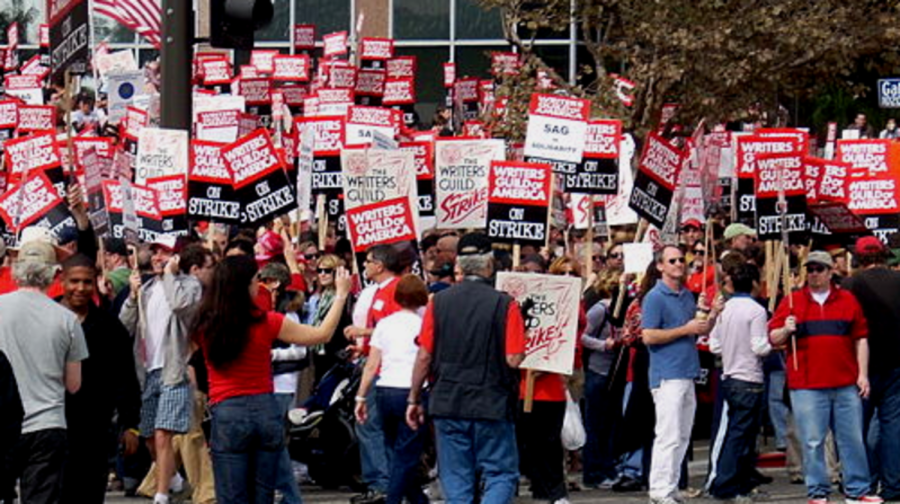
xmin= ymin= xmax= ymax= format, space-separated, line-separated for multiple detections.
xmin=0 ymin=230 xmax=88 ymax=503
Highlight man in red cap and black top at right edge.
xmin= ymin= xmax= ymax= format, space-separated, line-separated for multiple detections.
xmin=844 ymin=236 xmax=900 ymax=500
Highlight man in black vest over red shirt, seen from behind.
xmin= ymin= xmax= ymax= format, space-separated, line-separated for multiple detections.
xmin=406 ymin=233 xmax=525 ymax=502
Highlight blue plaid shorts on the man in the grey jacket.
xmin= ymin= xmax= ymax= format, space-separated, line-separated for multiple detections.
xmin=140 ymin=369 xmax=194 ymax=437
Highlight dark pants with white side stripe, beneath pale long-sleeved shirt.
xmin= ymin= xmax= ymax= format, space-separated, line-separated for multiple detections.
xmin=709 ymin=378 xmax=764 ymax=499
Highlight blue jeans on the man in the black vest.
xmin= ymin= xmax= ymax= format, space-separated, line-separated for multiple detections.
xmin=434 ymin=418 xmax=516 ymax=504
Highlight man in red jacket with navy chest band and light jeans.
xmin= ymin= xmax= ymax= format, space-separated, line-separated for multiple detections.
xmin=769 ymin=250 xmax=882 ymax=504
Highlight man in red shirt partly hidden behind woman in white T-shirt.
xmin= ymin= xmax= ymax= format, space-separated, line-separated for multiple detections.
xmin=344 ymin=245 xmax=403 ymax=503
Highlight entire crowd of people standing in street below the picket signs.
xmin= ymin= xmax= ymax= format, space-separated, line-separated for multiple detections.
xmin=0 ymin=170 xmax=900 ymax=504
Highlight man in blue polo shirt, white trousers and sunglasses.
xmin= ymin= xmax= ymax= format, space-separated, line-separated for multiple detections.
xmin=641 ymin=245 xmax=717 ymax=504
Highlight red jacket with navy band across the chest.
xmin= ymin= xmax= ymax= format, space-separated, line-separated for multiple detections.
xmin=769 ymin=286 xmax=869 ymax=389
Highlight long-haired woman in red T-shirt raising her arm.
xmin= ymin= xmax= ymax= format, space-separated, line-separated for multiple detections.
xmin=193 ymin=256 xmax=350 ymax=504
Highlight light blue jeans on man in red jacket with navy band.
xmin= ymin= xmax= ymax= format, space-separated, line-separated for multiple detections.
xmin=791 ymin=385 xmax=871 ymax=498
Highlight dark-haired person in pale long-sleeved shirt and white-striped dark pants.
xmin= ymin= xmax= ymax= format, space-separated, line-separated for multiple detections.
xmin=709 ymin=264 xmax=772 ymax=499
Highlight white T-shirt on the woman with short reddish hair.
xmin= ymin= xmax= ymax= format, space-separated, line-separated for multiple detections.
xmin=372 ymin=310 xmax=422 ymax=388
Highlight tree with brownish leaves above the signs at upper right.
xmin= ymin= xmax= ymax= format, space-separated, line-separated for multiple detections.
xmin=481 ymin=0 xmax=900 ymax=137
